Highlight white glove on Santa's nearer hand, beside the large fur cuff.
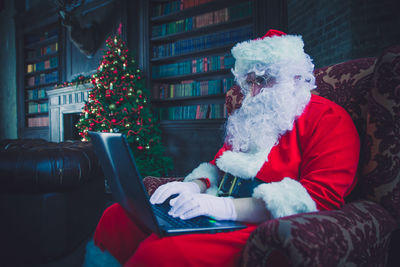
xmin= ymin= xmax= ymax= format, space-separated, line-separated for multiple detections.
xmin=168 ymin=193 xmax=237 ymax=221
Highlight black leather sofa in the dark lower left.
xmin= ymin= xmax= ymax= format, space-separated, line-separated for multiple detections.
xmin=0 ymin=139 xmax=104 ymax=266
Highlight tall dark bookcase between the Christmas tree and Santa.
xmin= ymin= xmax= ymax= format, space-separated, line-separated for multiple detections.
xmin=142 ymin=0 xmax=258 ymax=176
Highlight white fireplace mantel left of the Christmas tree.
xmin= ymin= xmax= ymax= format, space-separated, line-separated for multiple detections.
xmin=47 ymin=83 xmax=93 ymax=142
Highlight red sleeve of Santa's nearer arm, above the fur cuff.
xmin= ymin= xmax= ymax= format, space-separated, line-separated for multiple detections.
xmin=299 ymin=101 xmax=360 ymax=210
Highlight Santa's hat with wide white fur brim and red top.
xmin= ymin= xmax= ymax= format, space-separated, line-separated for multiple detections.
xmin=231 ymin=30 xmax=314 ymax=90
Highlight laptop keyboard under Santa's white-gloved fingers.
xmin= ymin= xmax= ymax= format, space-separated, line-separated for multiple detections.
xmin=152 ymin=199 xmax=211 ymax=228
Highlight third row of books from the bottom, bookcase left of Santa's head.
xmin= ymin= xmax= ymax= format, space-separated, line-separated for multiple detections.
xmin=151 ymin=54 xmax=235 ymax=79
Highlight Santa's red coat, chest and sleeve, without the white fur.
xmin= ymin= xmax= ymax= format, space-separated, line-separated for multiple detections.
xmin=210 ymin=95 xmax=360 ymax=213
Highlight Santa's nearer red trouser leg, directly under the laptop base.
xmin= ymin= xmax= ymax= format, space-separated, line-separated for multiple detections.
xmin=125 ymin=225 xmax=255 ymax=267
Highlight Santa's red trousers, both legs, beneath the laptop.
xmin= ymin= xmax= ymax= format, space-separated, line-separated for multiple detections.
xmin=94 ymin=204 xmax=256 ymax=267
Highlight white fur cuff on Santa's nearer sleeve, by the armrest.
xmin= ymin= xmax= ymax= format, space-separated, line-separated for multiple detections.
xmin=253 ymin=177 xmax=317 ymax=218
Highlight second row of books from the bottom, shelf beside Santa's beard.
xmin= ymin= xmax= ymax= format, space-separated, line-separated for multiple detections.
xmin=153 ymin=78 xmax=234 ymax=99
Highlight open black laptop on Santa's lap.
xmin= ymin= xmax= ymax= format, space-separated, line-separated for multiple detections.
xmin=88 ymin=131 xmax=246 ymax=237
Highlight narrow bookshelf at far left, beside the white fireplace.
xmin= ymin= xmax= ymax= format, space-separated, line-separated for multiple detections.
xmin=22 ymin=22 xmax=60 ymax=129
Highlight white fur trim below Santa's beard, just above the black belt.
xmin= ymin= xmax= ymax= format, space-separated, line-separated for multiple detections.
xmin=216 ymin=150 xmax=269 ymax=179
